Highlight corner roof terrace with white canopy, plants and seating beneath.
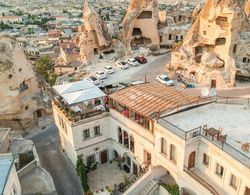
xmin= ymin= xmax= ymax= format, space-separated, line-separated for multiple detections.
xmin=53 ymin=80 xmax=107 ymax=122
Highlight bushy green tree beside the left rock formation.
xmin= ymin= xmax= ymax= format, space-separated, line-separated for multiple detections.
xmin=35 ymin=56 xmax=57 ymax=86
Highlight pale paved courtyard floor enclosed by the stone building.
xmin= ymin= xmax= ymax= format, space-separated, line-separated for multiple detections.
xmin=88 ymin=162 xmax=129 ymax=192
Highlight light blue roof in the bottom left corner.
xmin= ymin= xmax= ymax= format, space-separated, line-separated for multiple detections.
xmin=0 ymin=153 xmax=13 ymax=194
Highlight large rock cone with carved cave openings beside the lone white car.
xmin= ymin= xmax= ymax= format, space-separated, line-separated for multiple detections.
xmin=171 ymin=0 xmax=247 ymax=87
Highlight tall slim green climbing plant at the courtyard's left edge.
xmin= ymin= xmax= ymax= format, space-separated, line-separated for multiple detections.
xmin=76 ymin=157 xmax=89 ymax=193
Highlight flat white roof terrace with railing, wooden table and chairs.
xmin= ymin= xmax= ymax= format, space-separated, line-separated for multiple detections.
xmin=159 ymin=102 xmax=250 ymax=168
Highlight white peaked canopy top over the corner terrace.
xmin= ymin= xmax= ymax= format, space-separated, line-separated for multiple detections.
xmin=53 ymin=80 xmax=106 ymax=105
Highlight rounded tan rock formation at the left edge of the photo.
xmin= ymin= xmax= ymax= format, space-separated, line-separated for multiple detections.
xmin=0 ymin=36 xmax=48 ymax=128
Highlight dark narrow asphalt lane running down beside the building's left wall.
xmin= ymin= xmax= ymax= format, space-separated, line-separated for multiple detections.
xmin=30 ymin=124 xmax=83 ymax=195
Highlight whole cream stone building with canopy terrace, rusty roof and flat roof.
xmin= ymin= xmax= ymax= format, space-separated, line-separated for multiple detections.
xmin=53 ymin=81 xmax=250 ymax=195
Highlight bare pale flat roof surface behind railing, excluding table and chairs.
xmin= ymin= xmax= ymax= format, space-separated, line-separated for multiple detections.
xmin=164 ymin=103 xmax=250 ymax=158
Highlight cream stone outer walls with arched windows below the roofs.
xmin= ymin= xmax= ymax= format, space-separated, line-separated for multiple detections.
xmin=53 ymin=101 xmax=250 ymax=195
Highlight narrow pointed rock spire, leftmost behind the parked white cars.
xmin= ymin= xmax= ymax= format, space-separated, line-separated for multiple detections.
xmin=79 ymin=0 xmax=111 ymax=62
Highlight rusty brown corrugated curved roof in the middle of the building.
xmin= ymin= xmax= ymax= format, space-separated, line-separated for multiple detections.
xmin=110 ymin=83 xmax=201 ymax=117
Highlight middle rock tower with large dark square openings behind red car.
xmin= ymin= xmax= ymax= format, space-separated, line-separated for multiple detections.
xmin=123 ymin=0 xmax=160 ymax=50
